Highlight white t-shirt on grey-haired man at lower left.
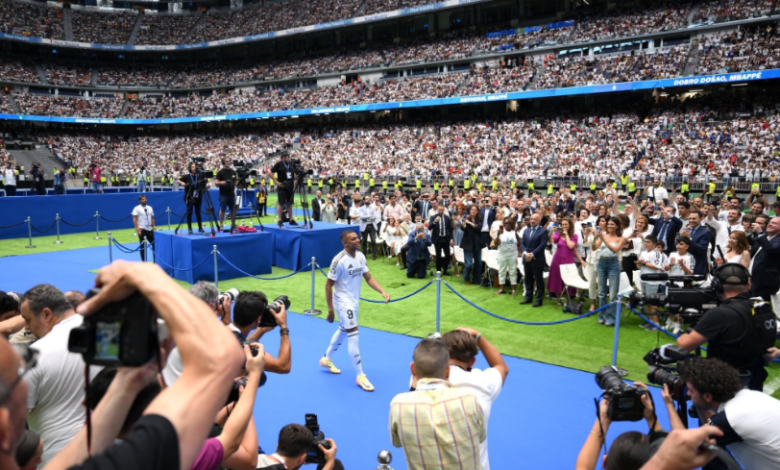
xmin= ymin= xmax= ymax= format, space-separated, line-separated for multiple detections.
xmin=25 ymin=315 xmax=101 ymax=468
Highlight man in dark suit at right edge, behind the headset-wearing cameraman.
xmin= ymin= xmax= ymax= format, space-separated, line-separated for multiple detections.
xmin=750 ymin=217 xmax=780 ymax=302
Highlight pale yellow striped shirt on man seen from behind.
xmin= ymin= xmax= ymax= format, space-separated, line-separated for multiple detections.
xmin=390 ymin=379 xmax=487 ymax=470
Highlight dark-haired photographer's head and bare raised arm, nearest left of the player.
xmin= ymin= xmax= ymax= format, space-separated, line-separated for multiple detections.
xmin=228 ymin=291 xmax=292 ymax=374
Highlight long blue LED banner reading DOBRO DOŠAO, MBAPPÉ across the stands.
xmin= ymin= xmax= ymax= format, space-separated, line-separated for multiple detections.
xmin=0 ymin=69 xmax=780 ymax=125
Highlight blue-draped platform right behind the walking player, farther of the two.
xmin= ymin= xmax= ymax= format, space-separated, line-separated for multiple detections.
xmin=256 ymin=220 xmax=358 ymax=271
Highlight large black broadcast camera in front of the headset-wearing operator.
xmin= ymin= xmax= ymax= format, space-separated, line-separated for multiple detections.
xmin=628 ymin=273 xmax=720 ymax=326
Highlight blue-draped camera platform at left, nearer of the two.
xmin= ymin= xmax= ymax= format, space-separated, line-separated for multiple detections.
xmin=155 ymin=230 xmax=274 ymax=284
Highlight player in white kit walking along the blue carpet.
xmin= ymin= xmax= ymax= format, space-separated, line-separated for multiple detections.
xmin=320 ymin=230 xmax=390 ymax=392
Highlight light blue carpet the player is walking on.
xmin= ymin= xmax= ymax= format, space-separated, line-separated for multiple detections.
xmin=0 ymin=245 xmax=669 ymax=470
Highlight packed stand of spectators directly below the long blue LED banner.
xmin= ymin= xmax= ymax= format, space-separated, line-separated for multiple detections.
xmin=7 ymin=86 xmax=780 ymax=184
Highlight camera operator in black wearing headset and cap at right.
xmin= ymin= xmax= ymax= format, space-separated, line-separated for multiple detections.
xmin=677 ymin=263 xmax=777 ymax=391
